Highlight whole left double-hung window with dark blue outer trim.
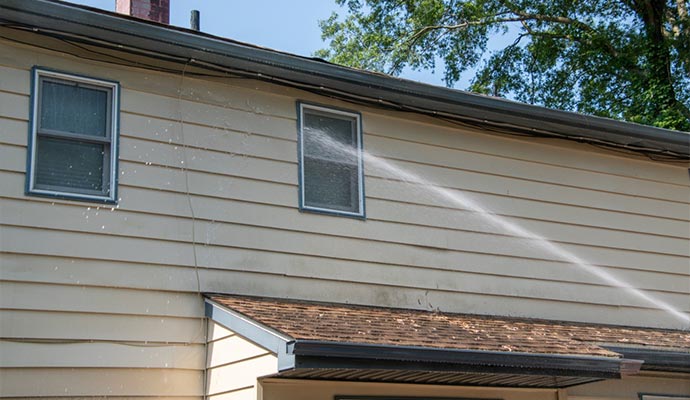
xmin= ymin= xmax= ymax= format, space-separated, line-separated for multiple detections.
xmin=27 ymin=68 xmax=119 ymax=203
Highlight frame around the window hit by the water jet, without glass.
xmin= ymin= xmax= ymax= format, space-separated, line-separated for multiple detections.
xmin=297 ymin=101 xmax=366 ymax=219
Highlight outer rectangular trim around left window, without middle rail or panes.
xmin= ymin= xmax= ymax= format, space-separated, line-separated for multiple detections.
xmin=26 ymin=67 xmax=120 ymax=203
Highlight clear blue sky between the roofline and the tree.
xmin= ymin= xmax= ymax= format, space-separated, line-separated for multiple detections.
xmin=69 ymin=0 xmax=448 ymax=88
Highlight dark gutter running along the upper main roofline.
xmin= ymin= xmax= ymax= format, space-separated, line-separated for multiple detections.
xmin=0 ymin=0 xmax=690 ymax=159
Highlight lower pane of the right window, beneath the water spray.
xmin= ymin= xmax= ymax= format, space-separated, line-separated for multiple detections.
xmin=304 ymin=157 xmax=359 ymax=213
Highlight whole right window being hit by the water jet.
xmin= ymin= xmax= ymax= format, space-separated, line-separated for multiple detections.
xmin=299 ymin=103 xmax=364 ymax=218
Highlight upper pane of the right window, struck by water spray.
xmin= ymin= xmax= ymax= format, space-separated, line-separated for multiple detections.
xmin=304 ymin=114 xmax=357 ymax=164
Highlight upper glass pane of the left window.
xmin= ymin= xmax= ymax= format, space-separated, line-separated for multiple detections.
xmin=40 ymin=80 xmax=109 ymax=136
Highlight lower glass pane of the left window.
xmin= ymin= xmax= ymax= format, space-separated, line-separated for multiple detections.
xmin=35 ymin=137 xmax=108 ymax=192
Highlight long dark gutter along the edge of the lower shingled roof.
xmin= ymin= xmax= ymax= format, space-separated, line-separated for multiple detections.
xmin=287 ymin=340 xmax=642 ymax=379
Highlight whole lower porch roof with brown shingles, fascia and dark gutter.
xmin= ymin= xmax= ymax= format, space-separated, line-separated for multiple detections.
xmin=207 ymin=294 xmax=690 ymax=387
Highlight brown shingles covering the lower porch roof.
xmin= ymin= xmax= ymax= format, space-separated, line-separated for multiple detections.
xmin=208 ymin=295 xmax=690 ymax=357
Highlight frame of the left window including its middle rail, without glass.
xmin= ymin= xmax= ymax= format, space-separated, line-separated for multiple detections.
xmin=25 ymin=66 xmax=120 ymax=204
